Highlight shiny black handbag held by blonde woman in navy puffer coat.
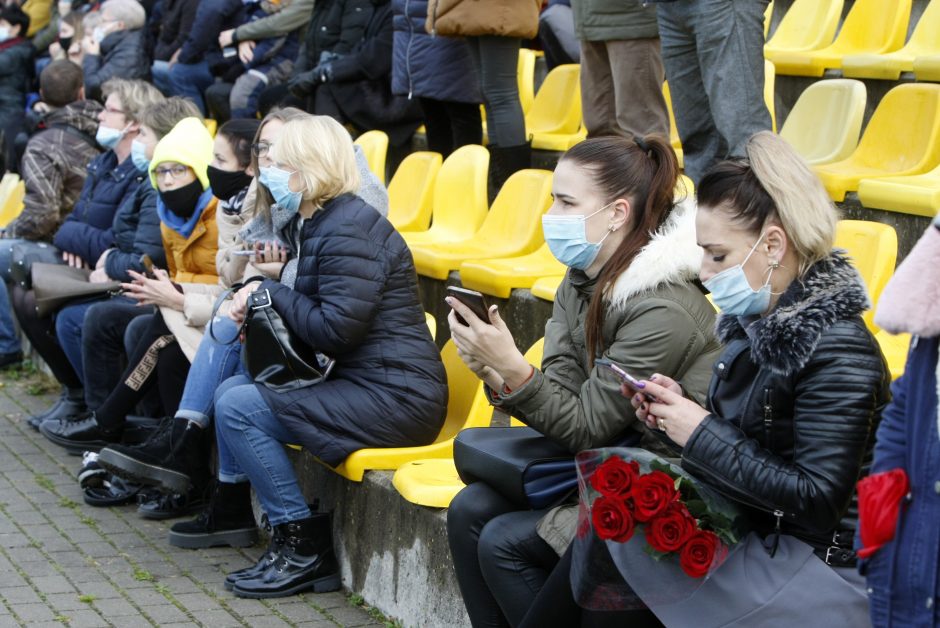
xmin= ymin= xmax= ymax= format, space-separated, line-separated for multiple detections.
xmin=209 ymin=277 xmax=336 ymax=392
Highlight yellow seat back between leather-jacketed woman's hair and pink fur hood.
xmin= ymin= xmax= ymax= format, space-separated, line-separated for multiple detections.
xmin=835 ymin=220 xmax=898 ymax=333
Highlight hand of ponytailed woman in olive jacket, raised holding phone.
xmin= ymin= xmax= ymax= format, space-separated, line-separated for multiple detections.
xmin=444 ymin=297 xmax=532 ymax=391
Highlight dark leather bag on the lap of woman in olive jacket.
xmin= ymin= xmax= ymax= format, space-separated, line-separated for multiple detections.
xmin=454 ymin=427 xmax=578 ymax=510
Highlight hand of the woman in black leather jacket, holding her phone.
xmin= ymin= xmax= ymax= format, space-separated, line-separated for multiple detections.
xmin=630 ymin=375 xmax=710 ymax=447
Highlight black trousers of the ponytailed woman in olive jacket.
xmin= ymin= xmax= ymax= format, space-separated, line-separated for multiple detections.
xmin=447 ymin=482 xmax=558 ymax=628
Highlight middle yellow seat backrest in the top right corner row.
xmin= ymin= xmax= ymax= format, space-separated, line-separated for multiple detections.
xmin=833 ymin=0 xmax=911 ymax=52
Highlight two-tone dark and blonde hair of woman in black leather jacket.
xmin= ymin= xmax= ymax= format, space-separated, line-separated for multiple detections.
xmin=696 ymin=131 xmax=838 ymax=275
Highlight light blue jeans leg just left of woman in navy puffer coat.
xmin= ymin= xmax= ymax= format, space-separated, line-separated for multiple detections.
xmin=176 ymin=316 xmax=246 ymax=429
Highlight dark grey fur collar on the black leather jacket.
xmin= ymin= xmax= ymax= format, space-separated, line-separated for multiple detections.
xmin=717 ymin=249 xmax=869 ymax=375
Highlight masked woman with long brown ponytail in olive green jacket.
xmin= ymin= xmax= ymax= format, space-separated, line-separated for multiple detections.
xmin=448 ymin=137 xmax=719 ymax=627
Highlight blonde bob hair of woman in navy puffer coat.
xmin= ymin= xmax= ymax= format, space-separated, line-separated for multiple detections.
xmin=271 ymin=115 xmax=359 ymax=208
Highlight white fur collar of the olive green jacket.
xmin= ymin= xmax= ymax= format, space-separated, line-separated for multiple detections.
xmin=609 ymin=199 xmax=702 ymax=307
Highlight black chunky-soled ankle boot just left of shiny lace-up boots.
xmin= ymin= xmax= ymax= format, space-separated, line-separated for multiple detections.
xmin=169 ymin=482 xmax=258 ymax=549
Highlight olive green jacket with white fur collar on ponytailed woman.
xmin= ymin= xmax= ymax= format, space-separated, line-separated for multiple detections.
xmin=487 ymin=201 xmax=721 ymax=551
